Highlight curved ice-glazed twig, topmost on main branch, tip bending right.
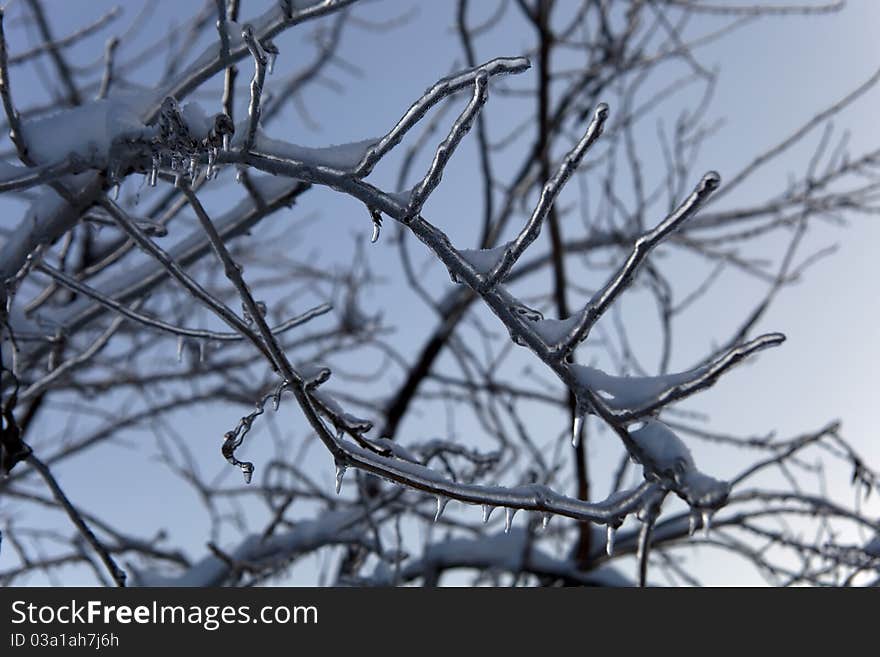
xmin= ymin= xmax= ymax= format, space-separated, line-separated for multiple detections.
xmin=354 ymin=57 xmax=530 ymax=178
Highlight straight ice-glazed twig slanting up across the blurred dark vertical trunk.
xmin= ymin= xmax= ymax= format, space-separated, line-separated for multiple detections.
xmin=486 ymin=103 xmax=608 ymax=287
